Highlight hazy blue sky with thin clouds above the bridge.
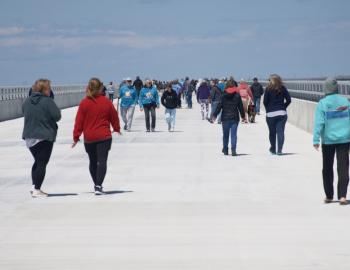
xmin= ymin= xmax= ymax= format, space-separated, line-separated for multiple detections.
xmin=0 ymin=0 xmax=350 ymax=85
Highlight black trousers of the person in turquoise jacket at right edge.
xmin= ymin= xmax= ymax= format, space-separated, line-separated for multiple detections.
xmin=322 ymin=143 xmax=350 ymax=199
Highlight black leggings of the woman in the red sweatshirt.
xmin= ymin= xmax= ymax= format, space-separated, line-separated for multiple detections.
xmin=84 ymin=139 xmax=112 ymax=187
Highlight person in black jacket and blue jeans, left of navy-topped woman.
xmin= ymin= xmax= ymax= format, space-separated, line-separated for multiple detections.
xmin=211 ymin=82 xmax=245 ymax=156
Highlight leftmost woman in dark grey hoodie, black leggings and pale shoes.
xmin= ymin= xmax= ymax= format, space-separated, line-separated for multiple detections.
xmin=22 ymin=79 xmax=61 ymax=198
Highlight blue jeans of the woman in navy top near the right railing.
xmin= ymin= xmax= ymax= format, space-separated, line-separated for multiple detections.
xmin=266 ymin=115 xmax=287 ymax=153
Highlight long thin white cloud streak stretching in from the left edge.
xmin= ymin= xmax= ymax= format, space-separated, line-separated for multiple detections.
xmin=0 ymin=29 xmax=255 ymax=51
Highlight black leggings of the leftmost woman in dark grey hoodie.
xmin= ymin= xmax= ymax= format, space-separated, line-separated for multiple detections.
xmin=29 ymin=141 xmax=53 ymax=189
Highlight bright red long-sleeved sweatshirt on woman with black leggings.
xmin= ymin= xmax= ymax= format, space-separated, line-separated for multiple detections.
xmin=73 ymin=95 xmax=120 ymax=142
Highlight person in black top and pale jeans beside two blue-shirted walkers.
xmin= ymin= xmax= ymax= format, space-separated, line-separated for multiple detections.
xmin=161 ymin=83 xmax=179 ymax=132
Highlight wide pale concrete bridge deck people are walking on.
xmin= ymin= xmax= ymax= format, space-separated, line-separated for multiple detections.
xmin=0 ymin=102 xmax=350 ymax=270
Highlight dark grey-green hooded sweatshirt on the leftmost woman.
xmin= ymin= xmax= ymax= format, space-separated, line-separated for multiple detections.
xmin=22 ymin=92 xmax=61 ymax=142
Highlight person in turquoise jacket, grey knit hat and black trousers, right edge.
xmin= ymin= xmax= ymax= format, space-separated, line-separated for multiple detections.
xmin=313 ymin=78 xmax=350 ymax=205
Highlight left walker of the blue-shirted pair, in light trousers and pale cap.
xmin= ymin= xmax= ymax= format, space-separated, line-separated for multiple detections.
xmin=119 ymin=78 xmax=137 ymax=131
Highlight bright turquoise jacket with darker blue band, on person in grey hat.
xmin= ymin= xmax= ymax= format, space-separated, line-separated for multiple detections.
xmin=313 ymin=94 xmax=350 ymax=145
